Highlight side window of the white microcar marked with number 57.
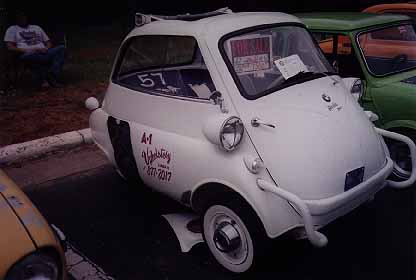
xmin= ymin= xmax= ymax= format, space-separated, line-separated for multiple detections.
xmin=113 ymin=35 xmax=215 ymax=99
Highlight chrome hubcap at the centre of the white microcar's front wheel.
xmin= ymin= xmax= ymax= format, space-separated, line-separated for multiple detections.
xmin=213 ymin=221 xmax=241 ymax=253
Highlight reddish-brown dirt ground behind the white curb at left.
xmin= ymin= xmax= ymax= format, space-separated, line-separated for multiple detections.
xmin=0 ymin=81 xmax=106 ymax=146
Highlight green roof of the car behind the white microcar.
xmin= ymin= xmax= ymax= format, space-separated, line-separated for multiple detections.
xmin=296 ymin=12 xmax=411 ymax=31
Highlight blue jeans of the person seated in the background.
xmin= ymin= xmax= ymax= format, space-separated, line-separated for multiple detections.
xmin=20 ymin=45 xmax=65 ymax=82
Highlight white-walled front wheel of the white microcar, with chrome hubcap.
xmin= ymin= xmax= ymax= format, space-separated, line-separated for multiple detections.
xmin=203 ymin=205 xmax=254 ymax=273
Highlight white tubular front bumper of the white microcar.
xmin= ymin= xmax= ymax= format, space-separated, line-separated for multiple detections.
xmin=257 ymin=128 xmax=416 ymax=247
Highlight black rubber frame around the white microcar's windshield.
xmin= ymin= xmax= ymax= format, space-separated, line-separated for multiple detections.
xmin=218 ymin=22 xmax=338 ymax=100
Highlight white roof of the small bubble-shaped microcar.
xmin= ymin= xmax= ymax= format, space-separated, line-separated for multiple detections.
xmin=128 ymin=12 xmax=303 ymax=39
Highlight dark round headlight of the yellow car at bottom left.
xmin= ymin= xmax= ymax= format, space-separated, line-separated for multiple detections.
xmin=5 ymin=253 xmax=59 ymax=280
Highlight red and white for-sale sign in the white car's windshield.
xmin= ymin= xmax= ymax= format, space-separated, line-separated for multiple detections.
xmin=229 ymin=35 xmax=272 ymax=74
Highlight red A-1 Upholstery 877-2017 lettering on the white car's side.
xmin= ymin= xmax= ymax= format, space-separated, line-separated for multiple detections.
xmin=141 ymin=132 xmax=172 ymax=182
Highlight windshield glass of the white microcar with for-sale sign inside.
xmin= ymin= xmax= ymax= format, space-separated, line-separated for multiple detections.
xmin=223 ymin=26 xmax=332 ymax=99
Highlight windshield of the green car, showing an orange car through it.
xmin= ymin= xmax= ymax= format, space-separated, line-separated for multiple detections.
xmin=358 ymin=24 xmax=416 ymax=76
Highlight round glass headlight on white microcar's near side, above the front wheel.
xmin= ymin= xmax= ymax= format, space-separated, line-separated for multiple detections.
xmin=220 ymin=116 xmax=244 ymax=151
